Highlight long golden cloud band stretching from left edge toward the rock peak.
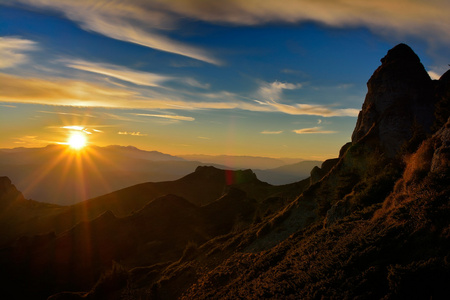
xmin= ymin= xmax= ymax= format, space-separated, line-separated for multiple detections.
xmin=0 ymin=73 xmax=359 ymax=117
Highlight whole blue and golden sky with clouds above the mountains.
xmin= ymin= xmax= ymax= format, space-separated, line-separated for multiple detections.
xmin=0 ymin=0 xmax=450 ymax=159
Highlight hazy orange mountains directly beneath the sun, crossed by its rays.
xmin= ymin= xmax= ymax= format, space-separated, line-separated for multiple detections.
xmin=0 ymin=145 xmax=229 ymax=205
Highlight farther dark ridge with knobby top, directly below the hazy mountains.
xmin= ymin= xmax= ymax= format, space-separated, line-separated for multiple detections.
xmin=0 ymin=166 xmax=309 ymax=246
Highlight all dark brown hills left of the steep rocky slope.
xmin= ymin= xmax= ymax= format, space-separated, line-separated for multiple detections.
xmin=0 ymin=166 xmax=308 ymax=299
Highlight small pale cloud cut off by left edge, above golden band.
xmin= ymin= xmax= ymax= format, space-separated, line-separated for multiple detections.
xmin=0 ymin=37 xmax=38 ymax=69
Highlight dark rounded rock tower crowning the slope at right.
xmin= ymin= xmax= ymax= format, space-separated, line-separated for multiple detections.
xmin=352 ymin=44 xmax=435 ymax=157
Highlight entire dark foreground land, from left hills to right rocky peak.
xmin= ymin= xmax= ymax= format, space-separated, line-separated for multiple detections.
xmin=0 ymin=44 xmax=450 ymax=299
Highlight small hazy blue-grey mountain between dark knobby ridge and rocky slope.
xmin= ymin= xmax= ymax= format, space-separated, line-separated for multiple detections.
xmin=253 ymin=160 xmax=322 ymax=185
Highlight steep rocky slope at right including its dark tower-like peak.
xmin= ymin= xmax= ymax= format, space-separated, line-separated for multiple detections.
xmin=110 ymin=45 xmax=450 ymax=299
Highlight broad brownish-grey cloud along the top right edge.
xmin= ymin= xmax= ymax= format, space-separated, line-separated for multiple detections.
xmin=152 ymin=0 xmax=450 ymax=44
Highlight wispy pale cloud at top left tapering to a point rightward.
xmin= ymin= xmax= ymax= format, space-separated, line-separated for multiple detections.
xmin=12 ymin=0 xmax=221 ymax=65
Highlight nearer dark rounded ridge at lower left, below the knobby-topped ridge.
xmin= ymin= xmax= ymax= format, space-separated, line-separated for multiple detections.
xmin=0 ymin=182 xmax=256 ymax=298
